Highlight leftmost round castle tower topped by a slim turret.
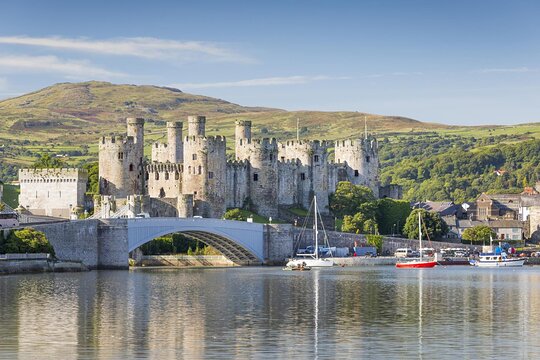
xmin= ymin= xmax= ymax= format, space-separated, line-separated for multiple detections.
xmin=99 ymin=118 xmax=144 ymax=198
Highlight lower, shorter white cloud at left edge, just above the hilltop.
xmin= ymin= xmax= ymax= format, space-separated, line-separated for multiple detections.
xmin=0 ymin=56 xmax=125 ymax=79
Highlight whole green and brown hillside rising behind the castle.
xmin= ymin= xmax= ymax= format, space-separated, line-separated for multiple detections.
xmin=0 ymin=82 xmax=540 ymax=200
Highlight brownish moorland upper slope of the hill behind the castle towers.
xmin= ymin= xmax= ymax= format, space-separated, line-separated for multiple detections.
xmin=0 ymin=81 xmax=447 ymax=139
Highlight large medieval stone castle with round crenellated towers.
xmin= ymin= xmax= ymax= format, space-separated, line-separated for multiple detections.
xmin=95 ymin=116 xmax=399 ymax=218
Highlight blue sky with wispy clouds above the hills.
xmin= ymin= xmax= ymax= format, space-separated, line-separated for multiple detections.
xmin=0 ymin=0 xmax=540 ymax=125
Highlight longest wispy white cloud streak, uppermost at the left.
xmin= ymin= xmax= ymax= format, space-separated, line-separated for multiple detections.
xmin=0 ymin=36 xmax=253 ymax=63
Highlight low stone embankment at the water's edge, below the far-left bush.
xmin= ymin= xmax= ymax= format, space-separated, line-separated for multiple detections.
xmin=0 ymin=254 xmax=88 ymax=275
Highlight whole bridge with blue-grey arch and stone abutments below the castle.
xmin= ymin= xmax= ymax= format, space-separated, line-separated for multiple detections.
xmin=29 ymin=218 xmax=282 ymax=269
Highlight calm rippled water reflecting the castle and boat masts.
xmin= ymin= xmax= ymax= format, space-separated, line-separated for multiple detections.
xmin=0 ymin=267 xmax=540 ymax=359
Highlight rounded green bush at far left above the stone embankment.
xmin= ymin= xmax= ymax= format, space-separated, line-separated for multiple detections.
xmin=0 ymin=228 xmax=54 ymax=255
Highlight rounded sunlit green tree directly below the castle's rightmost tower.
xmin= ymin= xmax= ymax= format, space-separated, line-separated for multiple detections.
xmin=330 ymin=181 xmax=375 ymax=218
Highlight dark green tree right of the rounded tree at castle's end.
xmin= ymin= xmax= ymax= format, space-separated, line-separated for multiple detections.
xmin=375 ymin=198 xmax=411 ymax=234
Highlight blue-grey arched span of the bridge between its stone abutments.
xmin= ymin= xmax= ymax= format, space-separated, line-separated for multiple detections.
xmin=127 ymin=218 xmax=264 ymax=264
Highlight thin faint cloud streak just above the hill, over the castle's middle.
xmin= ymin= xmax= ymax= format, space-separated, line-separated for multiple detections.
xmin=170 ymin=75 xmax=350 ymax=89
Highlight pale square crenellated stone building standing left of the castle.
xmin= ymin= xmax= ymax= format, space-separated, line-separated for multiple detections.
xmin=19 ymin=169 xmax=88 ymax=218
